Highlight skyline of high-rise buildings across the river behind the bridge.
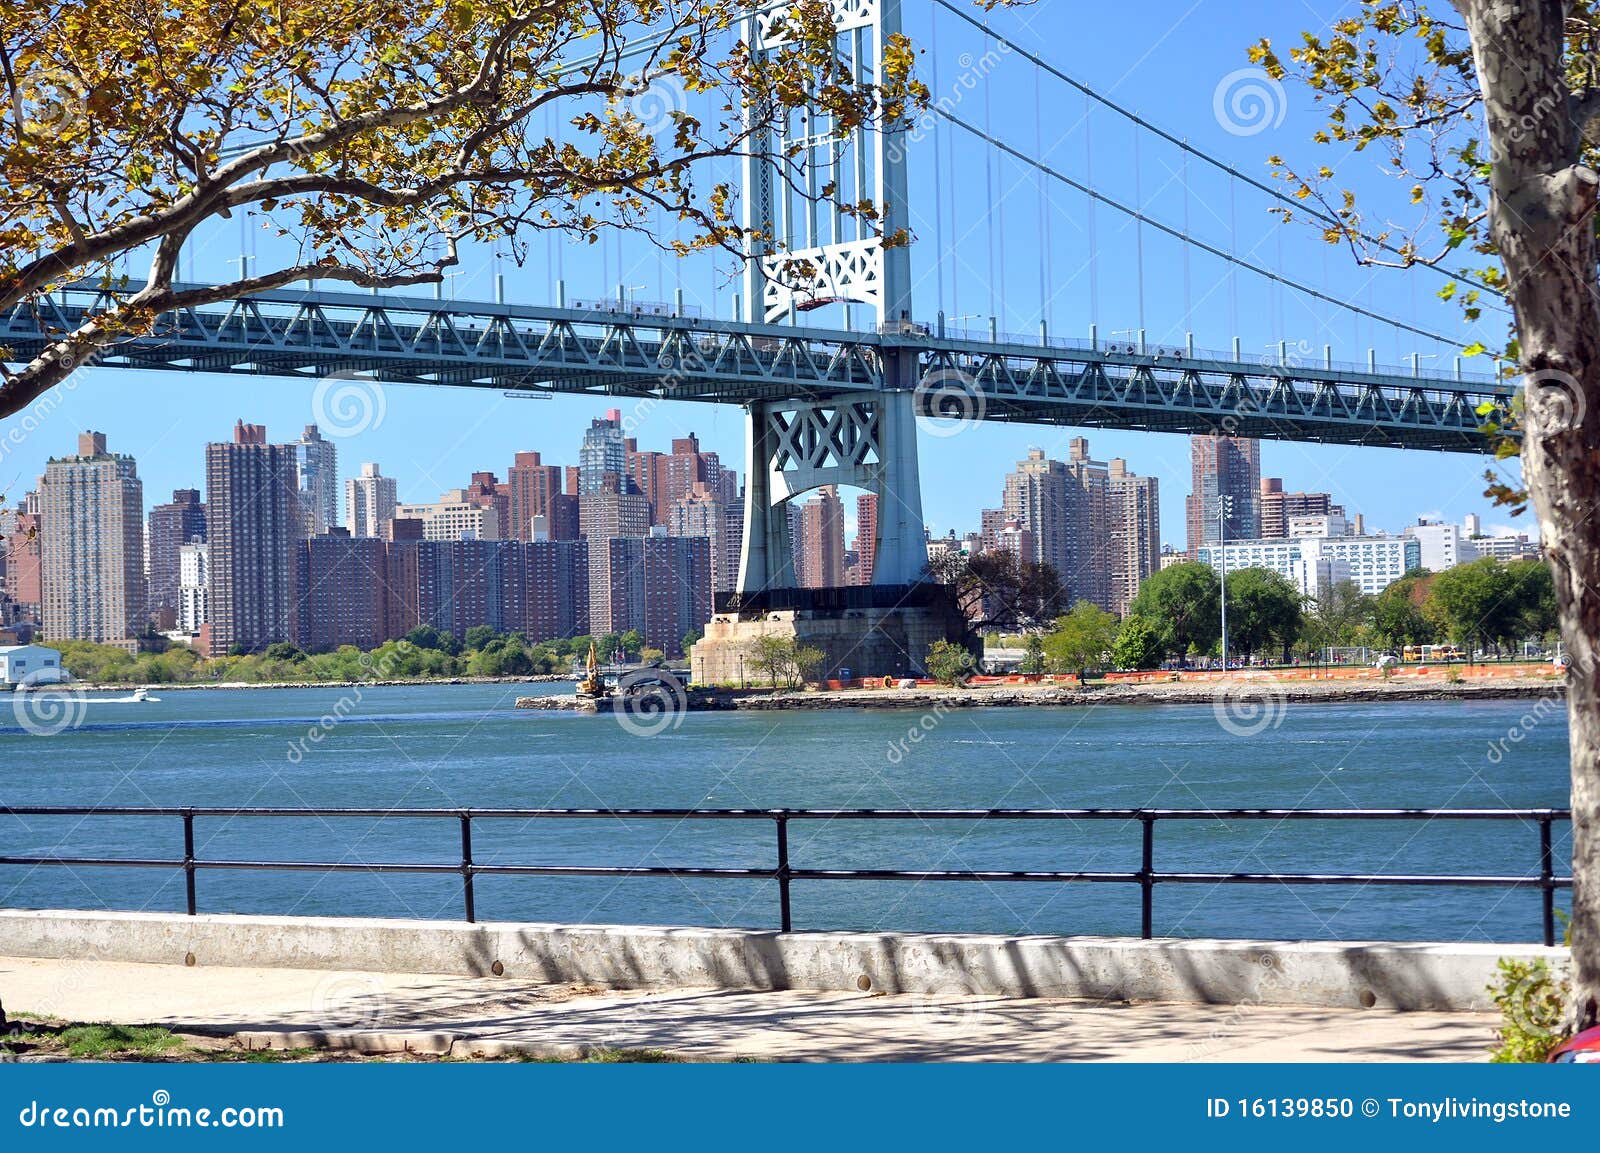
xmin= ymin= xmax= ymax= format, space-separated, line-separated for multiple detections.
xmin=0 ymin=408 xmax=1531 ymax=656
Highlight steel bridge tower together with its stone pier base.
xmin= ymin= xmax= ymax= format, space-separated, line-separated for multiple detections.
xmin=693 ymin=0 xmax=965 ymax=683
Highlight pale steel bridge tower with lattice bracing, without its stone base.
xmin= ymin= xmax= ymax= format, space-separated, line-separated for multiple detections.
xmin=739 ymin=0 xmax=928 ymax=598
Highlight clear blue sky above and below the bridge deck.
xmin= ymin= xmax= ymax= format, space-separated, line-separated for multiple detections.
xmin=0 ymin=0 xmax=1531 ymax=547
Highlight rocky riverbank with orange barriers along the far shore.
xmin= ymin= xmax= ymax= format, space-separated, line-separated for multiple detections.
xmin=517 ymin=675 xmax=1566 ymax=712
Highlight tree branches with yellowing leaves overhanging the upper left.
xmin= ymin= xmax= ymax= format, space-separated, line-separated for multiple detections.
xmin=0 ymin=0 xmax=926 ymax=416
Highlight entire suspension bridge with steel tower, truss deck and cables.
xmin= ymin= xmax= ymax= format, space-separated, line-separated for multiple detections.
xmin=0 ymin=0 xmax=1512 ymax=639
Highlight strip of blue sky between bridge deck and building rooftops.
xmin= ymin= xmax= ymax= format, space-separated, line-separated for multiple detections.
xmin=0 ymin=383 xmax=1533 ymax=550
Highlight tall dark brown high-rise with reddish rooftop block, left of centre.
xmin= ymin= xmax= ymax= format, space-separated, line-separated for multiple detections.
xmin=205 ymin=421 xmax=302 ymax=654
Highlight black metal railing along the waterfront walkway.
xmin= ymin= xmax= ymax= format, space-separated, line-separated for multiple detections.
xmin=0 ymin=804 xmax=1573 ymax=945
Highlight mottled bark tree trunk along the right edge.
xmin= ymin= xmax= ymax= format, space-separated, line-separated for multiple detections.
xmin=1456 ymin=0 xmax=1600 ymax=1028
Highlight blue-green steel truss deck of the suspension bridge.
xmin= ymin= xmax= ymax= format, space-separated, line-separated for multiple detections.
xmin=0 ymin=285 xmax=1512 ymax=453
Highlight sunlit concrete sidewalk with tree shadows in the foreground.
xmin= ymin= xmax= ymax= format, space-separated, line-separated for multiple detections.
xmin=0 ymin=958 xmax=1494 ymax=1062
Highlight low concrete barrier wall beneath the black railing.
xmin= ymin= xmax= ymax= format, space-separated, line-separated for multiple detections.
xmin=0 ymin=910 xmax=1568 ymax=1011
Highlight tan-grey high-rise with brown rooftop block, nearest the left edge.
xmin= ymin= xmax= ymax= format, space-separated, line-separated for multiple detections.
xmin=38 ymin=432 xmax=147 ymax=646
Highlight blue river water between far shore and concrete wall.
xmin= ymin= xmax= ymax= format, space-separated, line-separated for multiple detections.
xmin=0 ymin=684 xmax=1568 ymax=952
